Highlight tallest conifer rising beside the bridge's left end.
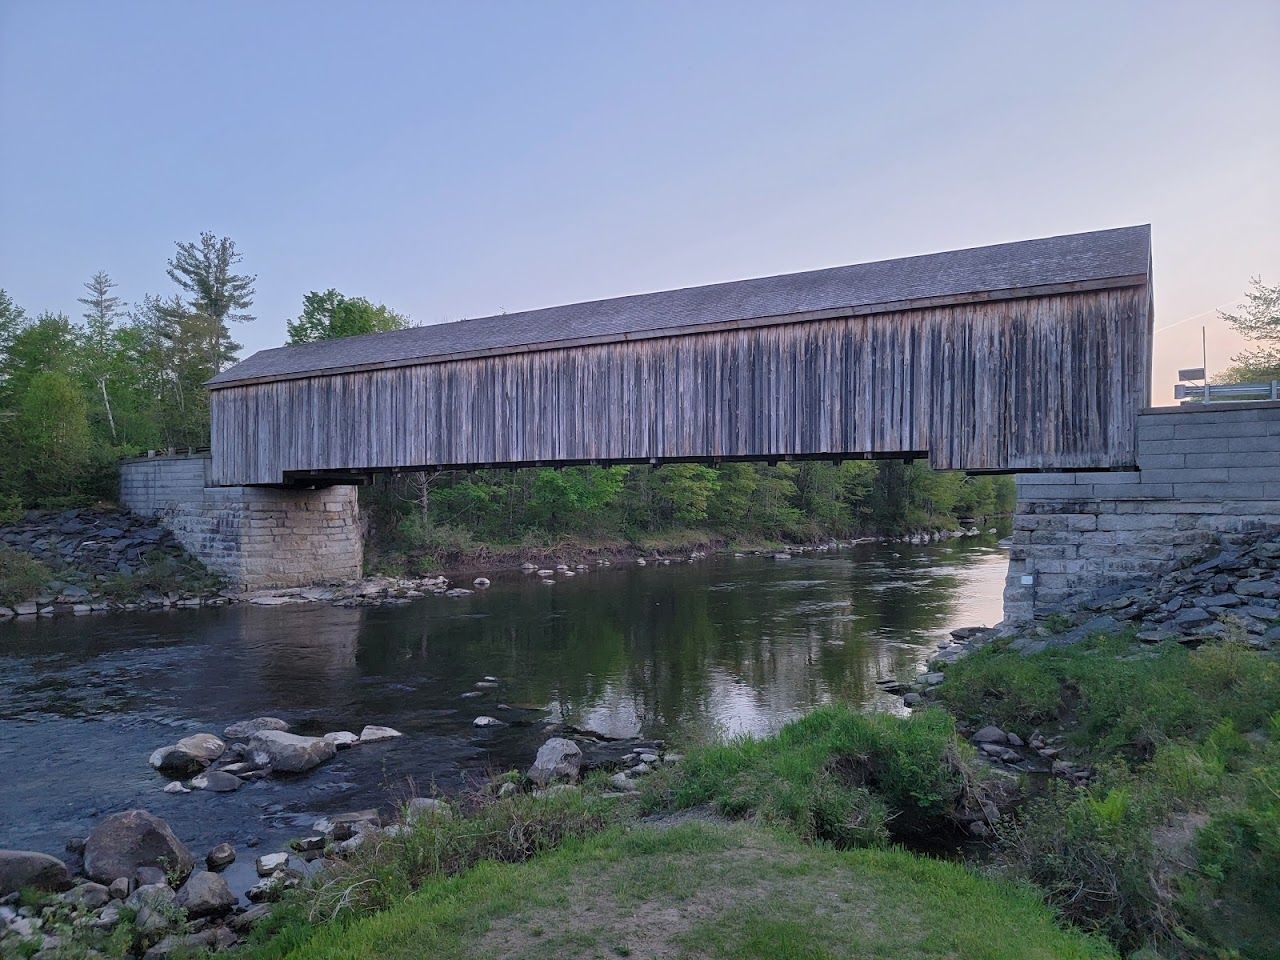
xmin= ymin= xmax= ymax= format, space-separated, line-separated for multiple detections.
xmin=161 ymin=230 xmax=257 ymax=379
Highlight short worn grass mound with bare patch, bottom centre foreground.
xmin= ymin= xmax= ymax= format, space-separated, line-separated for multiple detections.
xmin=247 ymin=823 xmax=1115 ymax=960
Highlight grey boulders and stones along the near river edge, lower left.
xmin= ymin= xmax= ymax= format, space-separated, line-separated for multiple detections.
xmin=0 ymin=716 xmax=680 ymax=960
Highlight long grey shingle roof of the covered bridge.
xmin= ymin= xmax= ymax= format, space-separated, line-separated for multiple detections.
xmin=209 ymin=225 xmax=1151 ymax=387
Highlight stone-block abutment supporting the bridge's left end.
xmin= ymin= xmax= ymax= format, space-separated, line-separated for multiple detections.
xmin=120 ymin=453 xmax=364 ymax=589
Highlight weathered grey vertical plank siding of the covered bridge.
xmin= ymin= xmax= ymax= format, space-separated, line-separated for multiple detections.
xmin=212 ymin=285 xmax=1151 ymax=484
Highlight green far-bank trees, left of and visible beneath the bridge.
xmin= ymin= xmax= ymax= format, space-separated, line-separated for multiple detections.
xmin=0 ymin=233 xmax=1012 ymax=547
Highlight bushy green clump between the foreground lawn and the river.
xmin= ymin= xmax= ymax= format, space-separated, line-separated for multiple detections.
xmin=648 ymin=705 xmax=975 ymax=847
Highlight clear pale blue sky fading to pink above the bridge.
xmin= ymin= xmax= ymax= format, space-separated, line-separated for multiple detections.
xmin=0 ymin=0 xmax=1280 ymax=402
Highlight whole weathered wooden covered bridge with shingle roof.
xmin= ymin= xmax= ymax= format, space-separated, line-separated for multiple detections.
xmin=209 ymin=227 xmax=1152 ymax=485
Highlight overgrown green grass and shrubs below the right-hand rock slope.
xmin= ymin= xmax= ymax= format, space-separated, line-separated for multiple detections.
xmin=938 ymin=636 xmax=1280 ymax=957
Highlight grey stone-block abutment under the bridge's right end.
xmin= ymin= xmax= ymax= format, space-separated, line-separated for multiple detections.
xmin=1005 ymin=402 xmax=1280 ymax=622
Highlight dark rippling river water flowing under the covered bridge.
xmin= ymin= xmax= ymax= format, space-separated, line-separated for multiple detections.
xmin=0 ymin=536 xmax=1007 ymax=870
